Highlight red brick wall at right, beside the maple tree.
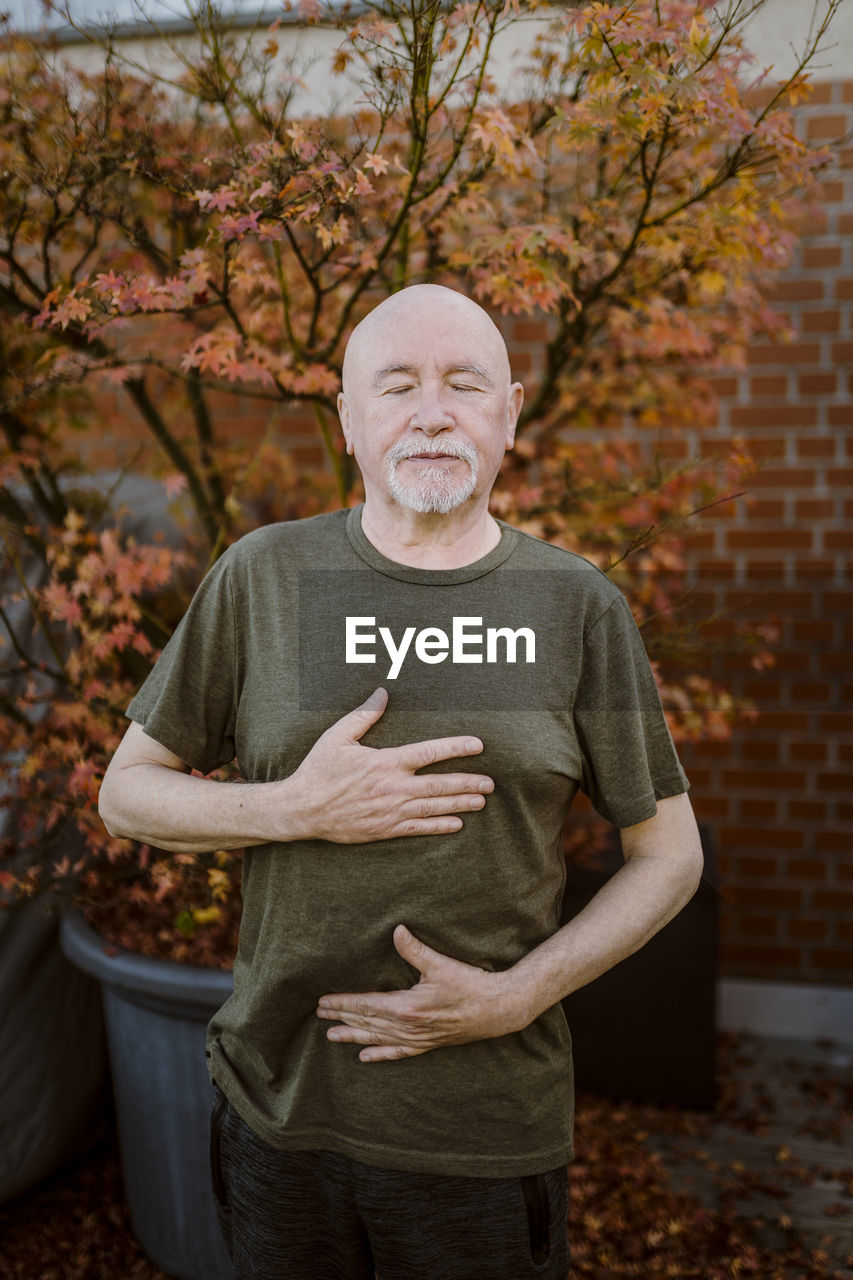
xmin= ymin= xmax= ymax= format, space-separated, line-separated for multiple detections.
xmin=684 ymin=83 xmax=853 ymax=983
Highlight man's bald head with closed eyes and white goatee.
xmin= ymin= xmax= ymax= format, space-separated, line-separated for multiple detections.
xmin=338 ymin=288 xmax=521 ymax=515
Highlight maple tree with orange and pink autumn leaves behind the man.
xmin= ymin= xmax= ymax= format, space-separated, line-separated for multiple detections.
xmin=0 ymin=0 xmax=840 ymax=959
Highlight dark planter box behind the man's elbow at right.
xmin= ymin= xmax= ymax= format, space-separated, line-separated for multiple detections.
xmin=562 ymin=829 xmax=717 ymax=1108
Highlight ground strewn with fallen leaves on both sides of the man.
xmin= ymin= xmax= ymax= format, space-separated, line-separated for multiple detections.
xmin=0 ymin=1036 xmax=853 ymax=1280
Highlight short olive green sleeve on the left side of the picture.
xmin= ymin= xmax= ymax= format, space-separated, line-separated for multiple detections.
xmin=127 ymin=553 xmax=237 ymax=773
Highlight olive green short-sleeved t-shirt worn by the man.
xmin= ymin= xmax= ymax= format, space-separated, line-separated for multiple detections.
xmin=128 ymin=508 xmax=688 ymax=1178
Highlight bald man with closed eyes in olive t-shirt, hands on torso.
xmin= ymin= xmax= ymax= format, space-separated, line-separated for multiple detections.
xmin=101 ymin=285 xmax=701 ymax=1280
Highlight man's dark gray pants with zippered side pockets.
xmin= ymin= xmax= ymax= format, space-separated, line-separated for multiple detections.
xmin=210 ymin=1092 xmax=569 ymax=1280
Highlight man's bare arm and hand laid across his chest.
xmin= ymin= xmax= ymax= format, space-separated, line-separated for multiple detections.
xmin=99 ymin=689 xmax=494 ymax=852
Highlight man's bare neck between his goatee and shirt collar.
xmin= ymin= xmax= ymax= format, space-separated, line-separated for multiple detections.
xmin=361 ymin=497 xmax=501 ymax=568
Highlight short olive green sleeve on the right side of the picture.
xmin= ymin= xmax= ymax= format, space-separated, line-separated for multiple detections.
xmin=574 ymin=595 xmax=689 ymax=827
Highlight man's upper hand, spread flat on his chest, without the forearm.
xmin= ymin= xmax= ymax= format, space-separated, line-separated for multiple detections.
xmin=281 ymin=689 xmax=494 ymax=845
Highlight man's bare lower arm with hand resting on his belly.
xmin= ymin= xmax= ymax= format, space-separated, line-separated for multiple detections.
xmin=318 ymin=795 xmax=702 ymax=1062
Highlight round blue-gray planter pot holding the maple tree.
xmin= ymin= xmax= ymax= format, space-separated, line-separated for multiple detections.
xmin=60 ymin=911 xmax=233 ymax=1280
